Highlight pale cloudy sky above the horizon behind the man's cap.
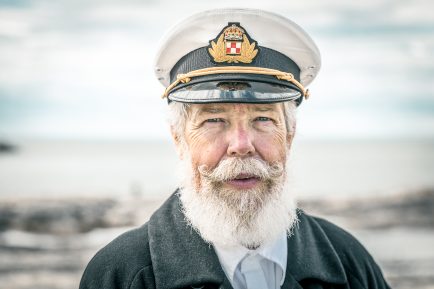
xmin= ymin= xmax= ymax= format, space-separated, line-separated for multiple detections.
xmin=0 ymin=0 xmax=434 ymax=141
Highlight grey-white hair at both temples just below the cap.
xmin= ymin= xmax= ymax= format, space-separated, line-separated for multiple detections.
xmin=168 ymin=100 xmax=297 ymax=140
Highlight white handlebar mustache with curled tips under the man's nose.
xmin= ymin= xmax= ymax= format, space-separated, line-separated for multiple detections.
xmin=198 ymin=157 xmax=284 ymax=182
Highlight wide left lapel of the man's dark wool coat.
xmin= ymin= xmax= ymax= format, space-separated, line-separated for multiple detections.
xmin=148 ymin=193 xmax=230 ymax=289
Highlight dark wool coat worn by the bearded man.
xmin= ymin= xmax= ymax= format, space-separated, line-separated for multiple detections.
xmin=80 ymin=194 xmax=389 ymax=289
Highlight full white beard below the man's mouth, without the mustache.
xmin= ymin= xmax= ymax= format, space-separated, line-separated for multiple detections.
xmin=179 ymin=153 xmax=298 ymax=248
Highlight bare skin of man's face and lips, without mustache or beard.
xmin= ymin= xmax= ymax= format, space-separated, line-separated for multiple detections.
xmin=181 ymin=103 xmax=292 ymax=191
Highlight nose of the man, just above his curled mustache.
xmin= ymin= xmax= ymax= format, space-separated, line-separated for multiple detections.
xmin=227 ymin=125 xmax=255 ymax=157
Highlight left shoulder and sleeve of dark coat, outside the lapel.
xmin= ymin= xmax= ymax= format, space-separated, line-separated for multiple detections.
xmin=80 ymin=224 xmax=154 ymax=289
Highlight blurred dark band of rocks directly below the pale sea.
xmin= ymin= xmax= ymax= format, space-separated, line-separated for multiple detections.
xmin=0 ymin=189 xmax=434 ymax=234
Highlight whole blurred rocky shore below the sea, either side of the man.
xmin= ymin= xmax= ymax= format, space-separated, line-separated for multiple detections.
xmin=0 ymin=190 xmax=434 ymax=289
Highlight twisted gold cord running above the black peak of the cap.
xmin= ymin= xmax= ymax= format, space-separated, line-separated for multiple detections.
xmin=162 ymin=66 xmax=309 ymax=99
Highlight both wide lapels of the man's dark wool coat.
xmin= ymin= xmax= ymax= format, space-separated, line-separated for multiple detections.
xmin=148 ymin=192 xmax=346 ymax=289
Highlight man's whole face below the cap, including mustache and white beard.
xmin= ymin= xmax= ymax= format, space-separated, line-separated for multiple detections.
xmin=175 ymin=100 xmax=297 ymax=248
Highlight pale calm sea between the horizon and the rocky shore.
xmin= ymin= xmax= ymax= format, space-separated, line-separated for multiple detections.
xmin=0 ymin=140 xmax=434 ymax=199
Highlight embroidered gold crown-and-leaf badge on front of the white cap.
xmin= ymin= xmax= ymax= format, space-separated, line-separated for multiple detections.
xmin=208 ymin=23 xmax=258 ymax=63
